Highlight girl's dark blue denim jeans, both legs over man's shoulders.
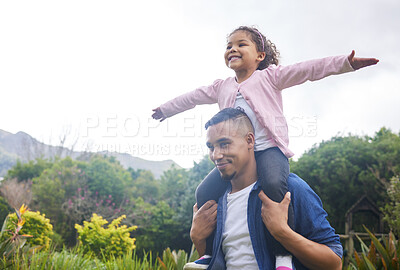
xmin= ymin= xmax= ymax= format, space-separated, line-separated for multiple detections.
xmin=196 ymin=147 xmax=293 ymax=255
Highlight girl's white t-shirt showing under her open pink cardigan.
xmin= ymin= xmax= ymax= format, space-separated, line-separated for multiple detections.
xmin=234 ymin=92 xmax=276 ymax=151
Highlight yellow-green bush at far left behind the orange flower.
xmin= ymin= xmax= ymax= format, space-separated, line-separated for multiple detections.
xmin=4 ymin=211 xmax=53 ymax=250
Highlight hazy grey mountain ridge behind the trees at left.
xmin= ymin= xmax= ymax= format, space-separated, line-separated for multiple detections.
xmin=0 ymin=129 xmax=180 ymax=178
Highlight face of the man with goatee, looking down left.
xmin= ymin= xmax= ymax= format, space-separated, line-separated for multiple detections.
xmin=207 ymin=120 xmax=254 ymax=181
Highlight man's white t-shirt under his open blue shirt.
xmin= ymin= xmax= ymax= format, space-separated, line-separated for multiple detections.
xmin=222 ymin=184 xmax=258 ymax=270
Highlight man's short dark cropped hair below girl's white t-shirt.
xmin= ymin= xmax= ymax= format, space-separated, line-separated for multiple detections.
xmin=205 ymin=108 xmax=254 ymax=133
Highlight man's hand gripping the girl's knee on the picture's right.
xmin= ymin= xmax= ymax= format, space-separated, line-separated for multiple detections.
xmin=258 ymin=191 xmax=290 ymax=238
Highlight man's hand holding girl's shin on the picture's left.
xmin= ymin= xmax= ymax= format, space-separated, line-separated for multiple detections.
xmin=190 ymin=201 xmax=218 ymax=256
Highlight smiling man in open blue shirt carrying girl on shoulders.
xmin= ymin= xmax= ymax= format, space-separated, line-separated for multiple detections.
xmin=190 ymin=108 xmax=343 ymax=269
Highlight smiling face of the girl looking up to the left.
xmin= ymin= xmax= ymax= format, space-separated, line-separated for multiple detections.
xmin=224 ymin=31 xmax=265 ymax=73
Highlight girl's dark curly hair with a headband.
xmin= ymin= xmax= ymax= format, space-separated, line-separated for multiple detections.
xmin=228 ymin=26 xmax=279 ymax=70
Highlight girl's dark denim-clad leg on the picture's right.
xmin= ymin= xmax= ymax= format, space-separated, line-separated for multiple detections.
xmin=255 ymin=147 xmax=294 ymax=255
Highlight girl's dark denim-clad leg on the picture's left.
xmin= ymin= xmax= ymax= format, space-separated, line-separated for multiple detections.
xmin=196 ymin=168 xmax=229 ymax=255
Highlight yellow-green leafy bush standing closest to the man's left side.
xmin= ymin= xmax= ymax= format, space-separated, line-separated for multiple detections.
xmin=75 ymin=214 xmax=136 ymax=258
